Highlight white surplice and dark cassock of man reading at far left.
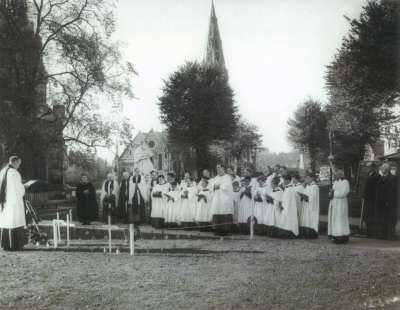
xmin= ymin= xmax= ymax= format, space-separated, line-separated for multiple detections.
xmin=0 ymin=165 xmax=27 ymax=251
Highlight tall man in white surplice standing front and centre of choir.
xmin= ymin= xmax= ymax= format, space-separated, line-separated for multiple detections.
xmin=211 ymin=164 xmax=233 ymax=235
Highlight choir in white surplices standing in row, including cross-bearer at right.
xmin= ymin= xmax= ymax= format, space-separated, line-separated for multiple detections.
xmin=152 ymin=165 xmax=350 ymax=243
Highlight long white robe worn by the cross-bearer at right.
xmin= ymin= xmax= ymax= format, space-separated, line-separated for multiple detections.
xmin=328 ymin=180 xmax=350 ymax=237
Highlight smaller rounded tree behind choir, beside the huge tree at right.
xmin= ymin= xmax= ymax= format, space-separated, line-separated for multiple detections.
xmin=288 ymin=99 xmax=328 ymax=172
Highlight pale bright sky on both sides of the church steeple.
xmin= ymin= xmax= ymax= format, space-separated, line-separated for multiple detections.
xmin=104 ymin=0 xmax=366 ymax=157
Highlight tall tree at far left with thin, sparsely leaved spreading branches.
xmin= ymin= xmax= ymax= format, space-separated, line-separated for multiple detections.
xmin=0 ymin=0 xmax=134 ymax=165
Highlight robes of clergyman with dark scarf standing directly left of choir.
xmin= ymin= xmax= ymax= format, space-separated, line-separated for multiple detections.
xmin=128 ymin=174 xmax=147 ymax=224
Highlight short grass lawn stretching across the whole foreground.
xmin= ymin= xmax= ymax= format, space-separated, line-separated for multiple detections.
xmin=0 ymin=238 xmax=400 ymax=310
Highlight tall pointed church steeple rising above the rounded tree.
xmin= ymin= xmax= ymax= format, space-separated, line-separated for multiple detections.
xmin=204 ymin=1 xmax=226 ymax=71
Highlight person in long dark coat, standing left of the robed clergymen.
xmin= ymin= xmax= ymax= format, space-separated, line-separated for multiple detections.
xmin=76 ymin=175 xmax=99 ymax=225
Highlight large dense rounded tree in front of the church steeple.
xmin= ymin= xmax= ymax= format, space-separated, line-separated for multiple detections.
xmin=158 ymin=62 xmax=237 ymax=171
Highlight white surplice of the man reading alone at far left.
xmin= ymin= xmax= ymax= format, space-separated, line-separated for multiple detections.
xmin=0 ymin=167 xmax=26 ymax=229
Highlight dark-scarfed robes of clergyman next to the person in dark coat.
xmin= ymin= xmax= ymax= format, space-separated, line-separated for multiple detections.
xmin=100 ymin=177 xmax=118 ymax=223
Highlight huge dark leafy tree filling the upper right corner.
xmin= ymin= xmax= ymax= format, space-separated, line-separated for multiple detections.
xmin=326 ymin=0 xmax=400 ymax=164
